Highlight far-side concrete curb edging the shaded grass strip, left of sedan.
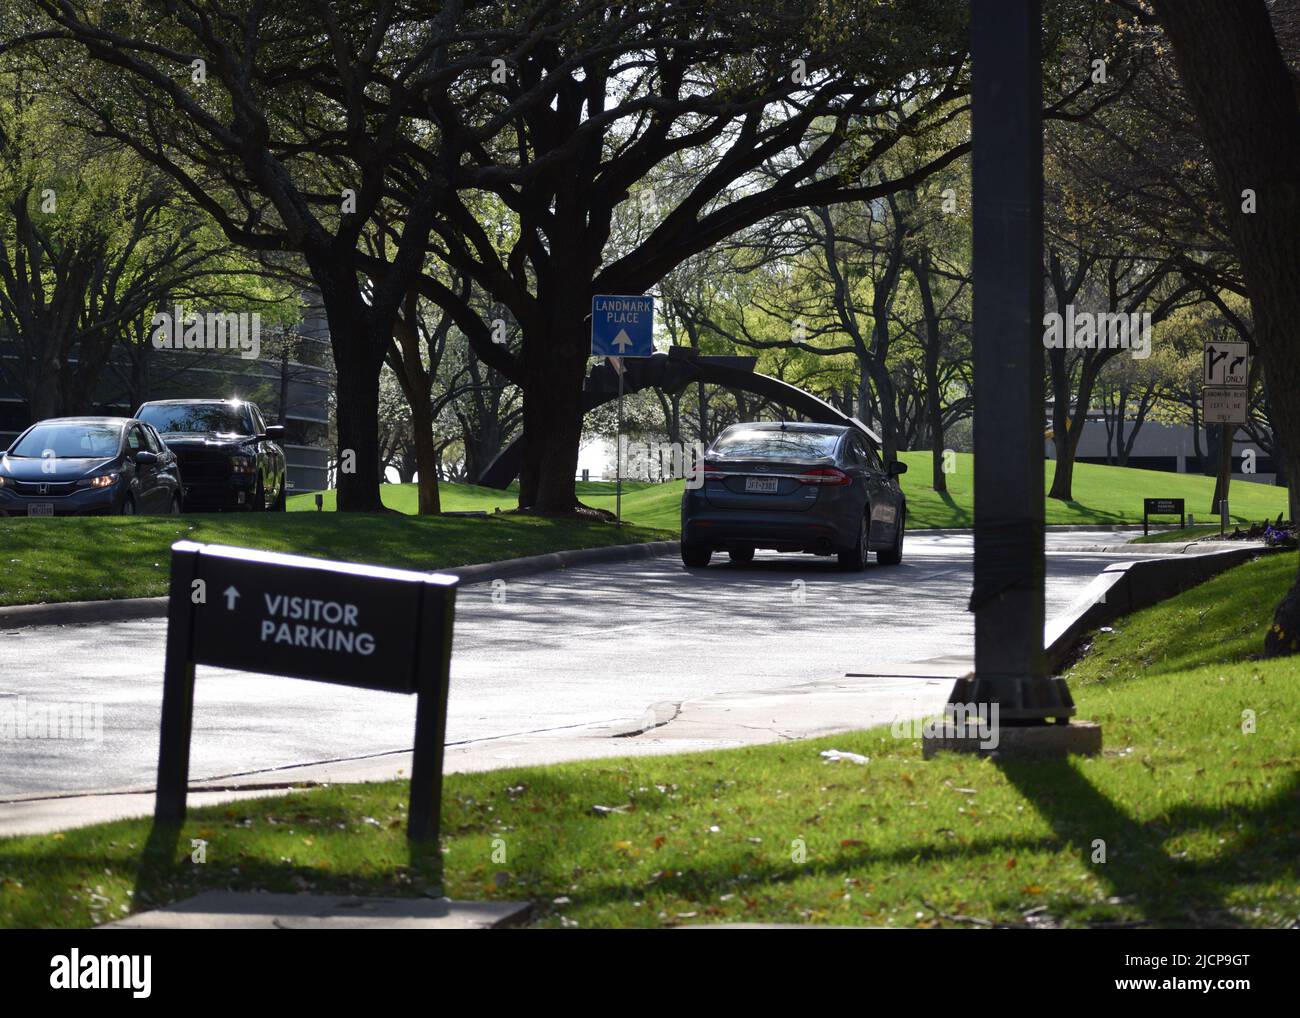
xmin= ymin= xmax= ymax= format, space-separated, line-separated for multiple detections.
xmin=0 ymin=541 xmax=681 ymax=631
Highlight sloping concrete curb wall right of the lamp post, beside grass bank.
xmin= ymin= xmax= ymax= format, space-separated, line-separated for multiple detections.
xmin=1044 ymin=545 xmax=1283 ymax=673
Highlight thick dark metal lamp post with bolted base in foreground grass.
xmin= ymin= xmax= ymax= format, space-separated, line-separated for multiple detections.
xmin=927 ymin=0 xmax=1075 ymax=750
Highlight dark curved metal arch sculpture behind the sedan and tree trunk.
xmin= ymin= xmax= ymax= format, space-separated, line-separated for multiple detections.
xmin=478 ymin=346 xmax=880 ymax=490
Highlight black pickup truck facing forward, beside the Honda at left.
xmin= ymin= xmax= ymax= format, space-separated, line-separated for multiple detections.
xmin=135 ymin=399 xmax=287 ymax=512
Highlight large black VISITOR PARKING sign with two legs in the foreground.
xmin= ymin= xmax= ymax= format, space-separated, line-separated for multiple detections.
xmin=153 ymin=541 xmax=458 ymax=840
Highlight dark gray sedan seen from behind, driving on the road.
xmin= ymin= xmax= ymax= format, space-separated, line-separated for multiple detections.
xmin=681 ymin=423 xmax=907 ymax=569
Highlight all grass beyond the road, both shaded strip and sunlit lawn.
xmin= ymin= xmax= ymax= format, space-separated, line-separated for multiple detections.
xmin=0 ymin=452 xmax=1286 ymax=605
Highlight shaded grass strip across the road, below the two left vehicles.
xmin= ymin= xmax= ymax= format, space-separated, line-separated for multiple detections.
xmin=0 ymin=512 xmax=672 ymax=605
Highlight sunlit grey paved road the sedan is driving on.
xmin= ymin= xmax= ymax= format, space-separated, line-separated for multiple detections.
xmin=0 ymin=533 xmax=1149 ymax=794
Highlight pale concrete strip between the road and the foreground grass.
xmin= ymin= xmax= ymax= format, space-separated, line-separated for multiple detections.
xmin=0 ymin=658 xmax=972 ymax=836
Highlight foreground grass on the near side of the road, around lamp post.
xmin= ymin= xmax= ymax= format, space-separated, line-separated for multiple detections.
xmin=0 ymin=555 xmax=1300 ymax=927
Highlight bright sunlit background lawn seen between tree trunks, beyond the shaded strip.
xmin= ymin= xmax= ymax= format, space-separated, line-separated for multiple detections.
xmin=297 ymin=452 xmax=1287 ymax=530
